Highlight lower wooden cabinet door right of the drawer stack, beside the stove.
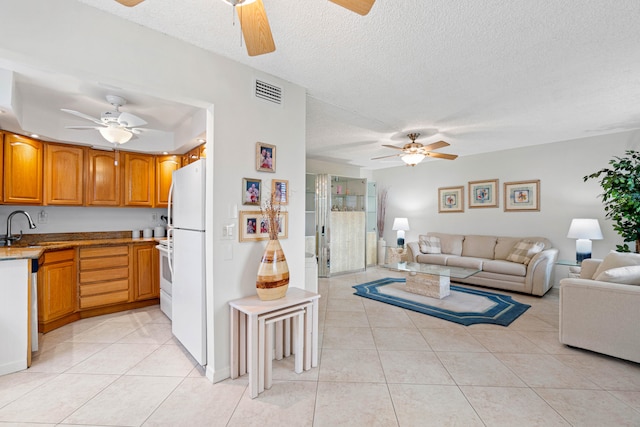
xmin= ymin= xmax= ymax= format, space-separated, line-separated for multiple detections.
xmin=132 ymin=242 xmax=160 ymax=301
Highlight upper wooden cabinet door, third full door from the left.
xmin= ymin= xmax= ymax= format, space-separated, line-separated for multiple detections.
xmin=86 ymin=149 xmax=120 ymax=206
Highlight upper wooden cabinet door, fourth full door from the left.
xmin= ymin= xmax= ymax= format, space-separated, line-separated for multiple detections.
xmin=122 ymin=153 xmax=155 ymax=208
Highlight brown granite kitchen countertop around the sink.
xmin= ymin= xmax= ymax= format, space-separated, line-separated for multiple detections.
xmin=0 ymin=233 xmax=166 ymax=261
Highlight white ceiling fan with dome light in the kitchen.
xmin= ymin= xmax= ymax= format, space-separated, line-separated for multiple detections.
xmin=61 ymin=95 xmax=147 ymax=144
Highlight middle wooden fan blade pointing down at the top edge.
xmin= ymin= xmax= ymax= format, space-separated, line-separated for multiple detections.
xmin=236 ymin=0 xmax=276 ymax=56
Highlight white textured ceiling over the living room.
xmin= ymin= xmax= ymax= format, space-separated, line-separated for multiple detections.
xmin=7 ymin=0 xmax=640 ymax=169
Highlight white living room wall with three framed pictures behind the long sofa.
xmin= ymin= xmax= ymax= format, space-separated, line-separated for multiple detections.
xmin=374 ymin=131 xmax=640 ymax=282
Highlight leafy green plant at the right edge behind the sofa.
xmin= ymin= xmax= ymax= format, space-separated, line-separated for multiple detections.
xmin=583 ymin=150 xmax=640 ymax=252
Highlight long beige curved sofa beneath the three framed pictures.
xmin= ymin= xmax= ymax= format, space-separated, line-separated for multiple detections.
xmin=407 ymin=233 xmax=558 ymax=296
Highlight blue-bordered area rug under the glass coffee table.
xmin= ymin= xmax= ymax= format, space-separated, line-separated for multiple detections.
xmin=354 ymin=277 xmax=531 ymax=326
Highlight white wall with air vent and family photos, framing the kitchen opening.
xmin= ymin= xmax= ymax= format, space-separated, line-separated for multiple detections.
xmin=0 ymin=0 xmax=306 ymax=381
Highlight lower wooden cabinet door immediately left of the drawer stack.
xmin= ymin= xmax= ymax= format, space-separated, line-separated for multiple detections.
xmin=38 ymin=249 xmax=77 ymax=333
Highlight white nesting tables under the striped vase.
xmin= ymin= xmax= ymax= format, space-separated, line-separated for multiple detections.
xmin=229 ymin=288 xmax=320 ymax=398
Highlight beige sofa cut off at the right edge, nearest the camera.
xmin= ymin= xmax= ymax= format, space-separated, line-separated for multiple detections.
xmin=560 ymin=254 xmax=640 ymax=363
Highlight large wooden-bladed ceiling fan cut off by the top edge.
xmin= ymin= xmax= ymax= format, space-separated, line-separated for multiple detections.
xmin=116 ymin=0 xmax=375 ymax=56
